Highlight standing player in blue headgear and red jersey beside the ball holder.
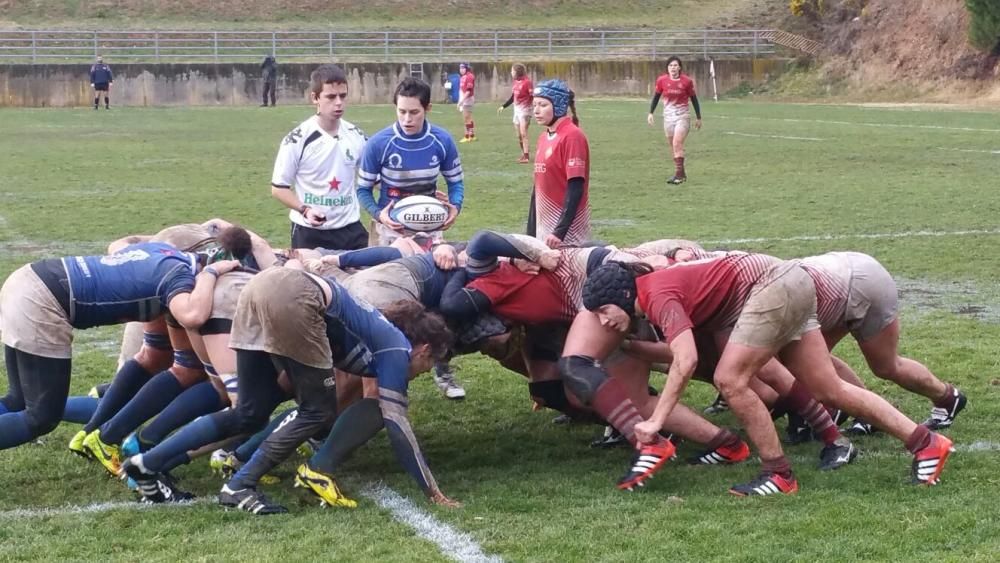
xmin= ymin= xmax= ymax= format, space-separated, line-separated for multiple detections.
xmin=528 ymin=79 xmax=590 ymax=248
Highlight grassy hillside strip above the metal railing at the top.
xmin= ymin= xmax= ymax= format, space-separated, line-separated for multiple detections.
xmin=0 ymin=0 xmax=787 ymax=30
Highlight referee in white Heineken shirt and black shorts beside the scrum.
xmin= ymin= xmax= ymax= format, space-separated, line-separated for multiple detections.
xmin=271 ymin=64 xmax=368 ymax=250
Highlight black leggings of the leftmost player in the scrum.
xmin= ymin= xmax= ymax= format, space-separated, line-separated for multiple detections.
xmin=0 ymin=345 xmax=72 ymax=439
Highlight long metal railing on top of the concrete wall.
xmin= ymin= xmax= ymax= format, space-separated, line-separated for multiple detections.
xmin=0 ymin=29 xmax=776 ymax=63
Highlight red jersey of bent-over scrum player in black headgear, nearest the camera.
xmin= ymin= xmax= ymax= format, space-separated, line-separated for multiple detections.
xmin=636 ymin=252 xmax=782 ymax=342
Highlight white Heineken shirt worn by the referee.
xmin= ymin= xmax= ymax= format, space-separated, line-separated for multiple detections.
xmin=271 ymin=115 xmax=367 ymax=230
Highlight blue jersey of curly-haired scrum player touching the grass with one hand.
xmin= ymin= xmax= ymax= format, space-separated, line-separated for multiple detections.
xmin=326 ymin=278 xmax=411 ymax=394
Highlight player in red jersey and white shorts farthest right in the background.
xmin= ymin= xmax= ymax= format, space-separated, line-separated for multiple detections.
xmin=646 ymin=57 xmax=701 ymax=185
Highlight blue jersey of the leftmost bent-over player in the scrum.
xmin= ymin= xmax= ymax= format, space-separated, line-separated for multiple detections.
xmin=62 ymin=242 xmax=197 ymax=328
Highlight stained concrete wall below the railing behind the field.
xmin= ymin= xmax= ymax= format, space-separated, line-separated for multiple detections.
xmin=0 ymin=59 xmax=785 ymax=107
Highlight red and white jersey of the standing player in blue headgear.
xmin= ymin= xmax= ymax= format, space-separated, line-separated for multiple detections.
xmin=535 ymin=117 xmax=590 ymax=245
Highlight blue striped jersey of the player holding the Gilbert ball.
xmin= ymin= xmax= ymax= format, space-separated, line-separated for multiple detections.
xmin=357 ymin=121 xmax=465 ymax=218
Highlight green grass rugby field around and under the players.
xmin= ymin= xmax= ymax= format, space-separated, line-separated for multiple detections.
xmin=0 ymin=100 xmax=1000 ymax=561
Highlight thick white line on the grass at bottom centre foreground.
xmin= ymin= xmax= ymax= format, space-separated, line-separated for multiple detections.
xmin=361 ymin=483 xmax=503 ymax=563
